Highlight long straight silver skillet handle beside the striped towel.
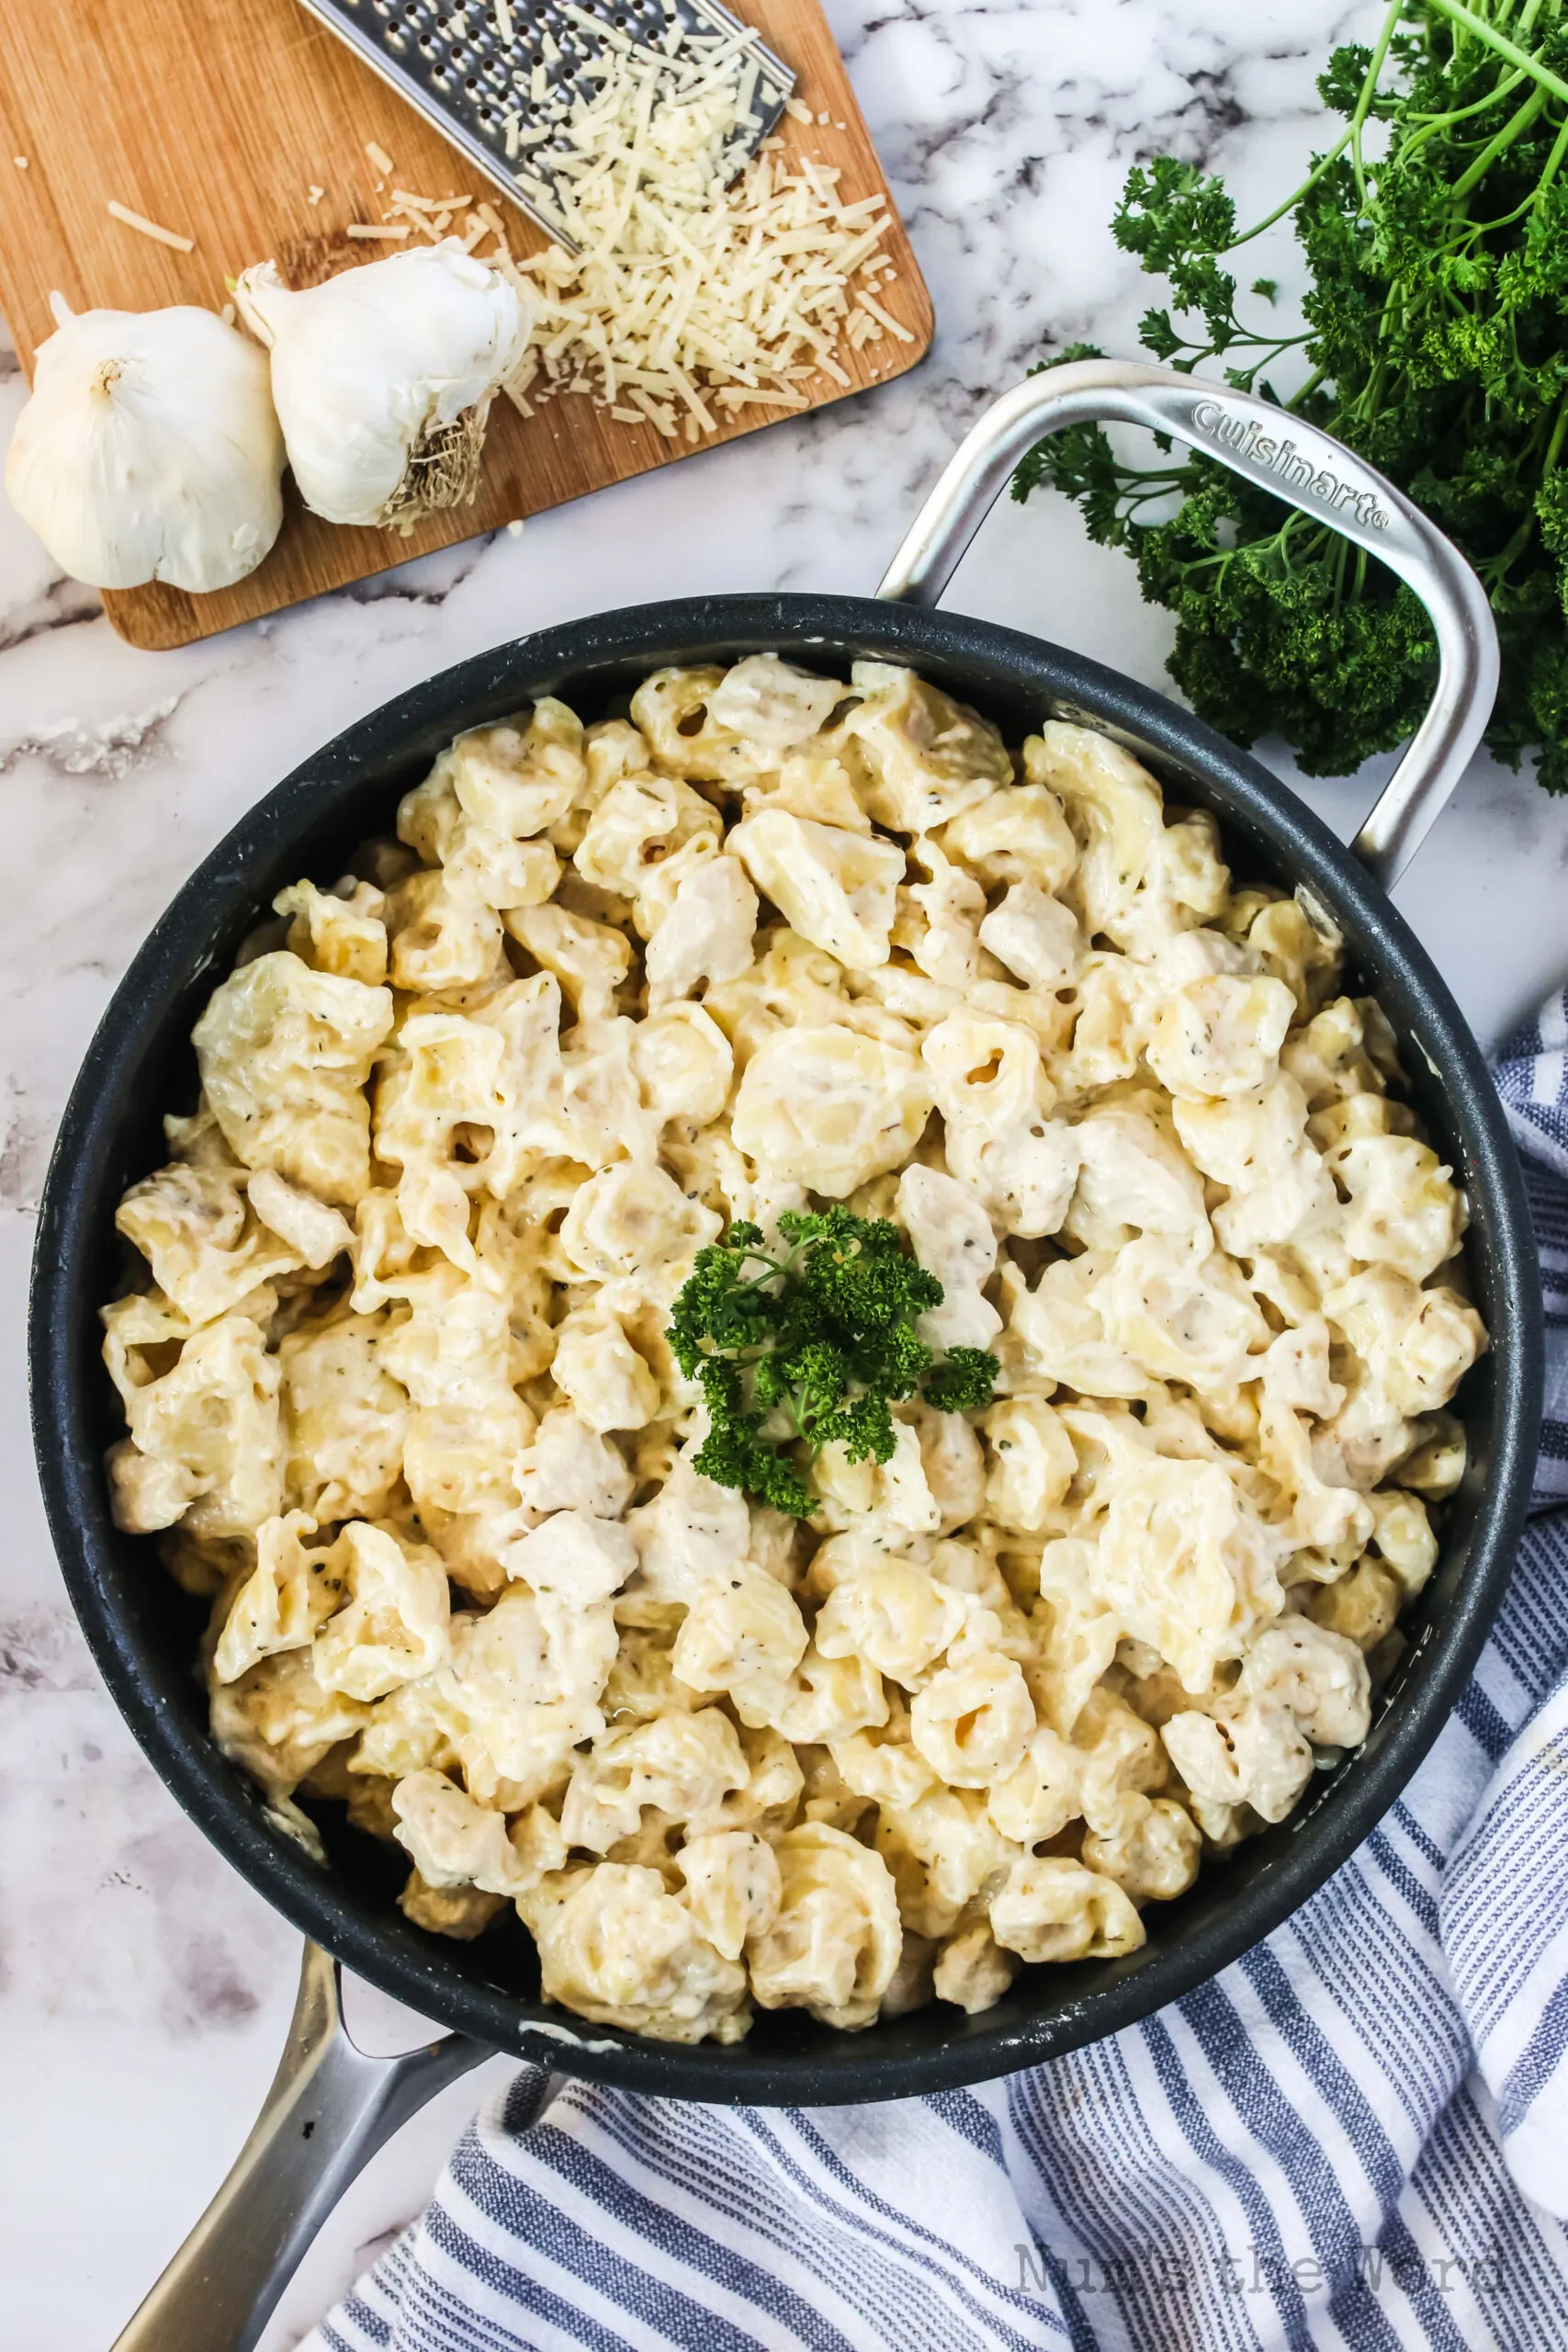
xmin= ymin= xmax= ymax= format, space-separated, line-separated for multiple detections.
xmin=113 ymin=1943 xmax=545 ymax=2352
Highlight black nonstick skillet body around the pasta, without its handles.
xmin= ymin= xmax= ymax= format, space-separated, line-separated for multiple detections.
xmin=30 ymin=595 xmax=1540 ymax=2105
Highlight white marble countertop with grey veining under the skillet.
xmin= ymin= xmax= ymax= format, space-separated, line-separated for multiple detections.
xmin=0 ymin=0 xmax=1568 ymax=2352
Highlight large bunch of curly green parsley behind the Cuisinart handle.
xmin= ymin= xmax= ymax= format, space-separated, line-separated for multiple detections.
xmin=1013 ymin=0 xmax=1568 ymax=793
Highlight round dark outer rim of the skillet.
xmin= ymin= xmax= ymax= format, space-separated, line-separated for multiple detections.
xmin=28 ymin=593 xmax=1542 ymax=2105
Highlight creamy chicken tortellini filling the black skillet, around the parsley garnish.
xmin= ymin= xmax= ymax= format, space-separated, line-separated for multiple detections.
xmin=104 ymin=654 xmax=1485 ymax=2041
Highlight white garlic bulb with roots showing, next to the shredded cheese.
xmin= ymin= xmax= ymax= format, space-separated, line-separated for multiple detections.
xmin=235 ymin=238 xmax=529 ymax=522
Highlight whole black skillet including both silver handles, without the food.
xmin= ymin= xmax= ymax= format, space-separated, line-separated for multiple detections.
xmin=30 ymin=362 xmax=1540 ymax=2352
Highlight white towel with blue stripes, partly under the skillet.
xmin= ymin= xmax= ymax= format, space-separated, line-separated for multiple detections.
xmin=303 ymin=995 xmax=1568 ymax=2352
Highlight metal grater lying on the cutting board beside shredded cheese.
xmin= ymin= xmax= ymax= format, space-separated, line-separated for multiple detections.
xmin=301 ymin=0 xmax=795 ymax=252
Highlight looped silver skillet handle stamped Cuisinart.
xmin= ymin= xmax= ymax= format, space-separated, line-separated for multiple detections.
xmin=877 ymin=360 xmax=1497 ymax=889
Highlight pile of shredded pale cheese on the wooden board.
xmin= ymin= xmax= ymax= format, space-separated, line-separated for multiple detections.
xmin=368 ymin=9 xmax=912 ymax=442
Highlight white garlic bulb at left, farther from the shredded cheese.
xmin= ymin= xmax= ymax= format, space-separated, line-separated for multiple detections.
xmin=5 ymin=294 xmax=282 ymax=595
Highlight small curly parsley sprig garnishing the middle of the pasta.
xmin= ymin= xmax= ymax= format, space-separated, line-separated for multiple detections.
xmin=668 ymin=1209 xmax=997 ymax=1520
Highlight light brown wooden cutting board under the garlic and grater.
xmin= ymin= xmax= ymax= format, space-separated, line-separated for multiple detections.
xmin=0 ymin=0 xmax=931 ymax=647
